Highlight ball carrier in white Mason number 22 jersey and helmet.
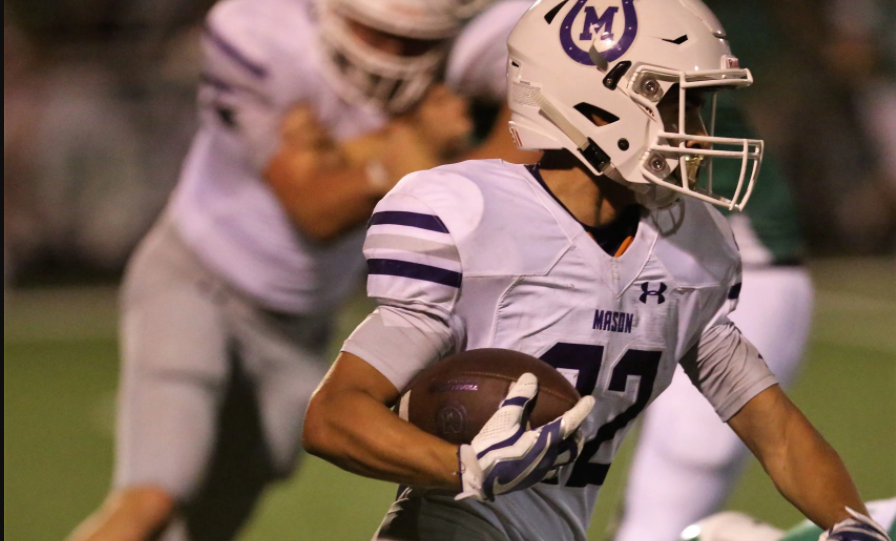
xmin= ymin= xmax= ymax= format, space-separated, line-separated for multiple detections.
xmin=303 ymin=0 xmax=886 ymax=540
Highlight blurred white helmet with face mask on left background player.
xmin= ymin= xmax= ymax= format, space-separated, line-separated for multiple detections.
xmin=317 ymin=0 xmax=462 ymax=113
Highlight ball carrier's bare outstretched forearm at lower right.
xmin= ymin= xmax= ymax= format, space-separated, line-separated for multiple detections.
xmin=730 ymin=386 xmax=866 ymax=528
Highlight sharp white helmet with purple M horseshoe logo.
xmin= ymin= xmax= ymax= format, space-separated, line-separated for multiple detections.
xmin=507 ymin=0 xmax=763 ymax=210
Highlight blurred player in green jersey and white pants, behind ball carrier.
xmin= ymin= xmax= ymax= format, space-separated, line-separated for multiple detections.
xmin=616 ymin=93 xmax=812 ymax=541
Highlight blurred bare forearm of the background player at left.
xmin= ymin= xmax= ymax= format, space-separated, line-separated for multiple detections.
xmin=265 ymin=155 xmax=383 ymax=242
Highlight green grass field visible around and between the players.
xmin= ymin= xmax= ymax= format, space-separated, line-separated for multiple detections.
xmin=3 ymin=259 xmax=896 ymax=541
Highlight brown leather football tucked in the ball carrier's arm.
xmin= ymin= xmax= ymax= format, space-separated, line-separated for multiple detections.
xmin=398 ymin=349 xmax=580 ymax=444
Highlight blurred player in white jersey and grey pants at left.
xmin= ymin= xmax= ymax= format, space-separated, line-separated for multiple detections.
xmin=72 ymin=0 xmax=527 ymax=541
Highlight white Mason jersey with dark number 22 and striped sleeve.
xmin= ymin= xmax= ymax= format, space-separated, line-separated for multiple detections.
xmin=343 ymin=160 xmax=775 ymax=540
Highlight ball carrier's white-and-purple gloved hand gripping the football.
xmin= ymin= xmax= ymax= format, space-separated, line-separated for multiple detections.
xmin=456 ymin=373 xmax=594 ymax=501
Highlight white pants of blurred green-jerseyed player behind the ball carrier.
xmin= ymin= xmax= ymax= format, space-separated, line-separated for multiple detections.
xmin=615 ymin=267 xmax=812 ymax=541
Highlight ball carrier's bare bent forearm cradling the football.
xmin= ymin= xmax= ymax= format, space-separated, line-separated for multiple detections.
xmin=302 ymin=380 xmax=459 ymax=491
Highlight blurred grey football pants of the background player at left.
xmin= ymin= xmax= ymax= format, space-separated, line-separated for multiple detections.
xmin=114 ymin=217 xmax=330 ymax=541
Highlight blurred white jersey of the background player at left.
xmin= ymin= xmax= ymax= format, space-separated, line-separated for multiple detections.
xmin=169 ymin=0 xmax=522 ymax=313
